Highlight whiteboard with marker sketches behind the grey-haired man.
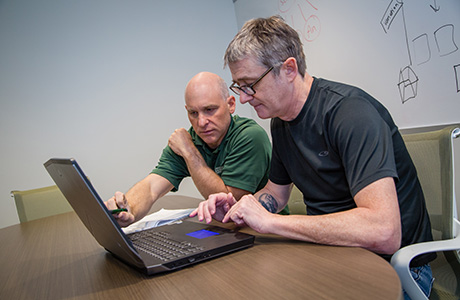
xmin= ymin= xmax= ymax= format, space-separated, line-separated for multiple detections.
xmin=235 ymin=0 xmax=460 ymax=128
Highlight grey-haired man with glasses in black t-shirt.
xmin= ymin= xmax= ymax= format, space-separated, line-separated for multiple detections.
xmin=192 ymin=17 xmax=435 ymax=294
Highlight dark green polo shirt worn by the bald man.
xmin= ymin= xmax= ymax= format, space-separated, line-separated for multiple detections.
xmin=152 ymin=115 xmax=271 ymax=193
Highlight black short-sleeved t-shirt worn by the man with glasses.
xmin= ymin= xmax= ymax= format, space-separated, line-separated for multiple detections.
xmin=270 ymin=78 xmax=432 ymax=265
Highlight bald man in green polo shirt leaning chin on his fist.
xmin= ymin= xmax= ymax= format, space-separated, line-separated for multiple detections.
xmin=106 ymin=72 xmax=271 ymax=226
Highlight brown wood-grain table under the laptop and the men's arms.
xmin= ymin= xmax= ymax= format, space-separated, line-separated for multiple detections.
xmin=0 ymin=196 xmax=402 ymax=300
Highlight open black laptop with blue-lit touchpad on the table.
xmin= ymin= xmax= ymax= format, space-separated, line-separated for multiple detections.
xmin=44 ymin=158 xmax=254 ymax=275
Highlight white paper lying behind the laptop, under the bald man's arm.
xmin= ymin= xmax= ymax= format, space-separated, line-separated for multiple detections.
xmin=122 ymin=208 xmax=195 ymax=234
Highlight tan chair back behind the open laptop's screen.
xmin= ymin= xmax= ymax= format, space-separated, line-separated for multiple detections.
xmin=11 ymin=185 xmax=72 ymax=223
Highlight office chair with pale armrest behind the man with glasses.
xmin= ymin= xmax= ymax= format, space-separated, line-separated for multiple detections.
xmin=391 ymin=126 xmax=460 ymax=300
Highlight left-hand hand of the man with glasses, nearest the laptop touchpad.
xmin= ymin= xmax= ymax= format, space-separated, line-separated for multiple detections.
xmin=190 ymin=193 xmax=236 ymax=223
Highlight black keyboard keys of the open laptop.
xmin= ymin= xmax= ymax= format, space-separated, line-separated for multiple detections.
xmin=129 ymin=230 xmax=204 ymax=261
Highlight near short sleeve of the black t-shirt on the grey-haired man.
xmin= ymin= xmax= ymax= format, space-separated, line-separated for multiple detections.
xmin=327 ymin=97 xmax=397 ymax=196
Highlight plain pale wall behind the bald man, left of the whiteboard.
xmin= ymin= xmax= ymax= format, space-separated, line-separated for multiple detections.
xmin=0 ymin=0 xmax=251 ymax=228
